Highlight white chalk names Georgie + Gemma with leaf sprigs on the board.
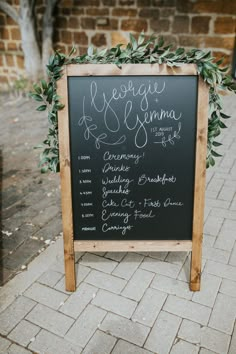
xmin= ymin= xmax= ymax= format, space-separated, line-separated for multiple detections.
xmin=78 ymin=80 xmax=182 ymax=149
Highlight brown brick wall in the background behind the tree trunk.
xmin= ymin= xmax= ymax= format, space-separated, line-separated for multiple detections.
xmin=0 ymin=0 xmax=236 ymax=86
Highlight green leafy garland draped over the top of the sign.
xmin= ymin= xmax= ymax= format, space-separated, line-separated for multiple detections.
xmin=30 ymin=33 xmax=236 ymax=172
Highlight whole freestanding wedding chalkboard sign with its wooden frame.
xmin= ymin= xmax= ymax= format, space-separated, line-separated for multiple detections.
xmin=59 ymin=64 xmax=208 ymax=288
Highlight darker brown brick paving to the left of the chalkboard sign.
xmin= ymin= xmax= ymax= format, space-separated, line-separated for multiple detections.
xmin=0 ymin=96 xmax=61 ymax=285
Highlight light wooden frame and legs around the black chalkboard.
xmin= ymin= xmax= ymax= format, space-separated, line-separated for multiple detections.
xmin=57 ymin=64 xmax=209 ymax=291
